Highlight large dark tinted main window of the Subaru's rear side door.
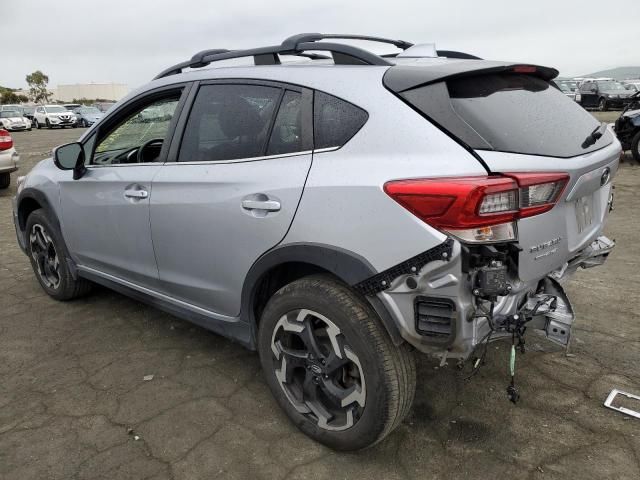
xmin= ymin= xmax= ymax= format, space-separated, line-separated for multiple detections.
xmin=178 ymin=85 xmax=282 ymax=162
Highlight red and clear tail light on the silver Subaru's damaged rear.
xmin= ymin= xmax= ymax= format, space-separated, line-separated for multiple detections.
xmin=384 ymin=173 xmax=569 ymax=243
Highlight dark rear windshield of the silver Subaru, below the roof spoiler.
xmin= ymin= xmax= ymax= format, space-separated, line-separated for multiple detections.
xmin=401 ymin=74 xmax=613 ymax=157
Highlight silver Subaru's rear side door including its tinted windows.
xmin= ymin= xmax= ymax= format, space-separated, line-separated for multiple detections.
xmin=151 ymin=81 xmax=313 ymax=316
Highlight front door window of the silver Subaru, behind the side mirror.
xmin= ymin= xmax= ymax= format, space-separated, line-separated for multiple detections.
xmin=91 ymin=93 xmax=180 ymax=165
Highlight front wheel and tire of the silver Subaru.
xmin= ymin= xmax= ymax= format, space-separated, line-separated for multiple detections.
xmin=26 ymin=209 xmax=91 ymax=301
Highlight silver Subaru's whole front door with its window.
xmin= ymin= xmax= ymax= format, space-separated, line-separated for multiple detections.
xmin=60 ymin=90 xmax=181 ymax=287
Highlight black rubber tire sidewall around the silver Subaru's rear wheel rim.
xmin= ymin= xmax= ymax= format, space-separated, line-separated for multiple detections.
xmin=258 ymin=282 xmax=396 ymax=450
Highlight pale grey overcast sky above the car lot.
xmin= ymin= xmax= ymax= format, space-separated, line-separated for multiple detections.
xmin=0 ymin=0 xmax=640 ymax=88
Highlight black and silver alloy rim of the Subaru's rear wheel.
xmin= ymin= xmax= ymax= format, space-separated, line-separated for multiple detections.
xmin=271 ymin=309 xmax=366 ymax=431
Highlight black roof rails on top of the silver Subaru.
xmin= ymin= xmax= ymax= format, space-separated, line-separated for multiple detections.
xmin=154 ymin=33 xmax=413 ymax=80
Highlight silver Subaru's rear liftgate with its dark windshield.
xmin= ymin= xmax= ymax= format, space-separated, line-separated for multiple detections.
xmin=402 ymin=73 xmax=620 ymax=281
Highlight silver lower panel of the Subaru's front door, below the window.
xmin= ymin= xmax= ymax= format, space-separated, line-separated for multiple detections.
xmin=58 ymin=164 xmax=162 ymax=288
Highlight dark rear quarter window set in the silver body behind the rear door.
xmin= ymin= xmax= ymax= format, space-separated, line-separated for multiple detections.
xmin=313 ymin=92 xmax=369 ymax=148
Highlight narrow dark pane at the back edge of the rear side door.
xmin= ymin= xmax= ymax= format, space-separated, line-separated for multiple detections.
xmin=267 ymin=90 xmax=303 ymax=155
